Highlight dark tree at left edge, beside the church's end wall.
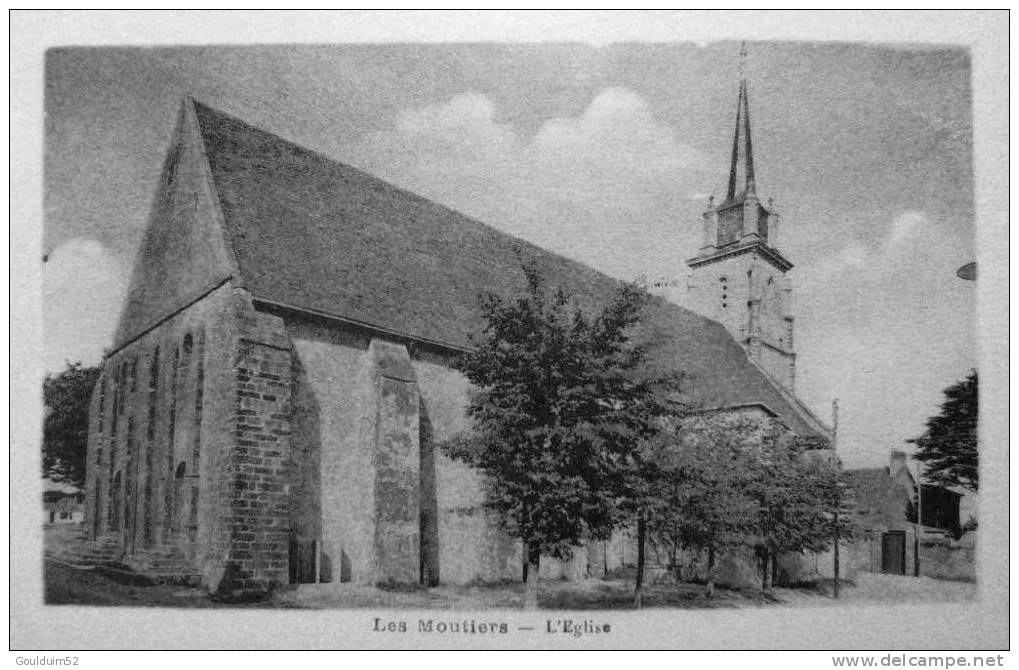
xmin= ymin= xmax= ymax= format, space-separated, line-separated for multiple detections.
xmin=43 ymin=362 xmax=100 ymax=487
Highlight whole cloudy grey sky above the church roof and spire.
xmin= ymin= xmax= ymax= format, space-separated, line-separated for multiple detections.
xmin=43 ymin=42 xmax=976 ymax=467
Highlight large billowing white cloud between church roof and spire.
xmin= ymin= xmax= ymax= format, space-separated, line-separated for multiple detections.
xmin=343 ymin=87 xmax=703 ymax=278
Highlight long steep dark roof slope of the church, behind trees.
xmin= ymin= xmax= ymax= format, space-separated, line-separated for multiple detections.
xmin=179 ymin=103 xmax=826 ymax=436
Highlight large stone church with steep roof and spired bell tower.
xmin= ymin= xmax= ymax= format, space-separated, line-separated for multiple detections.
xmin=79 ymin=63 xmax=829 ymax=596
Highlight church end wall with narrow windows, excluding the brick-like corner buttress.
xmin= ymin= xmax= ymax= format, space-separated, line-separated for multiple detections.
xmin=86 ymin=286 xmax=230 ymax=574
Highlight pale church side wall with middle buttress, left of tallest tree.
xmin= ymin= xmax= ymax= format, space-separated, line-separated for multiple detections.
xmin=286 ymin=315 xmax=521 ymax=583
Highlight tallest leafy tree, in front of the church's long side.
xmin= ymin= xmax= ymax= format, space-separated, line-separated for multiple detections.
xmin=442 ymin=268 xmax=680 ymax=609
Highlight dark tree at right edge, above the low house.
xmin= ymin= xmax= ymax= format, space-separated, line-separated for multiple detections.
xmin=909 ymin=370 xmax=980 ymax=492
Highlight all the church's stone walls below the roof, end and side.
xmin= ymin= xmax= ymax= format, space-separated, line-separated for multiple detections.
xmin=86 ymin=295 xmax=835 ymax=597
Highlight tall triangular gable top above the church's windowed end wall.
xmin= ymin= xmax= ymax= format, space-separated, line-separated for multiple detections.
xmin=114 ymin=98 xmax=236 ymax=349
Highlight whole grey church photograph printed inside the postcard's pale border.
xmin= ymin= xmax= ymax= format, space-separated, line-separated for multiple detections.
xmin=17 ymin=9 xmax=1007 ymax=648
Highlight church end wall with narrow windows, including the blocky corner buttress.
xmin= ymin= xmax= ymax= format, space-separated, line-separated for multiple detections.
xmin=86 ymin=283 xmax=294 ymax=596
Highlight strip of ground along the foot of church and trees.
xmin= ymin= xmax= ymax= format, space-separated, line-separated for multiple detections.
xmin=45 ymin=560 xmax=976 ymax=610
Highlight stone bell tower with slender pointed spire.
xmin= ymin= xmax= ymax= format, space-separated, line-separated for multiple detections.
xmin=687 ymin=43 xmax=796 ymax=392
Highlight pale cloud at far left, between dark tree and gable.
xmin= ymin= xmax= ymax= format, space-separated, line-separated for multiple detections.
xmin=43 ymin=237 xmax=127 ymax=372
